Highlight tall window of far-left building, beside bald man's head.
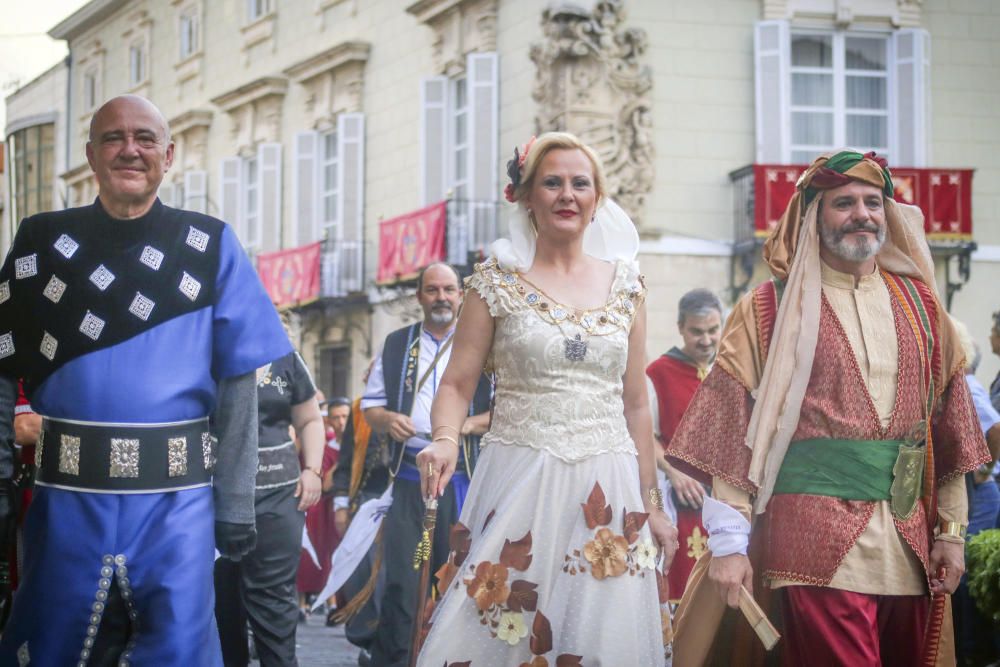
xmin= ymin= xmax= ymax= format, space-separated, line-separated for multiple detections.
xmin=9 ymin=123 xmax=55 ymax=226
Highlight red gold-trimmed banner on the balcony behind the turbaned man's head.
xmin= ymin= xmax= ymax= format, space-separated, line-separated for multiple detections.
xmin=753 ymin=164 xmax=972 ymax=241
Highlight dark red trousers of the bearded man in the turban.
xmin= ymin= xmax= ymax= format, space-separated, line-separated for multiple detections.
xmin=781 ymin=586 xmax=929 ymax=667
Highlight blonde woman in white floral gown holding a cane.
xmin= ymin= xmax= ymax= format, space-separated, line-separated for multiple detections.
xmin=417 ymin=133 xmax=677 ymax=667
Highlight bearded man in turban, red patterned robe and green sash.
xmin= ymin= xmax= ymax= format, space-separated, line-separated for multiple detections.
xmin=667 ymin=151 xmax=989 ymax=666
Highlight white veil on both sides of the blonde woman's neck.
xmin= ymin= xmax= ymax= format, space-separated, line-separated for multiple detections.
xmin=490 ymin=197 xmax=639 ymax=278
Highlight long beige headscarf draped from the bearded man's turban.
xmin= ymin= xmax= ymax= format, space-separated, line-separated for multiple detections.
xmin=740 ymin=151 xmax=948 ymax=514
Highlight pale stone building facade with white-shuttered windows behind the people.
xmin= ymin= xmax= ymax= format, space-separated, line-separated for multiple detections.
xmin=8 ymin=0 xmax=1000 ymax=394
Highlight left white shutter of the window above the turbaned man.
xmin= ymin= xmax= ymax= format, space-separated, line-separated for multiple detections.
xmin=753 ymin=21 xmax=791 ymax=164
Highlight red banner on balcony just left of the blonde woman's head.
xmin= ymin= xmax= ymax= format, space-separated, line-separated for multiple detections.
xmin=375 ymin=201 xmax=447 ymax=284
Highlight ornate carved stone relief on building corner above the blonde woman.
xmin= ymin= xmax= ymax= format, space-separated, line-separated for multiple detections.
xmin=531 ymin=0 xmax=654 ymax=225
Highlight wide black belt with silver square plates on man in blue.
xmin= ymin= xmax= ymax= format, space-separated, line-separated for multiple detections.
xmin=35 ymin=417 xmax=215 ymax=493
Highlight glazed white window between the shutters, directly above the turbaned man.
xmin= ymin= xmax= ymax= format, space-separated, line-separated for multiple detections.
xmin=790 ymin=32 xmax=889 ymax=163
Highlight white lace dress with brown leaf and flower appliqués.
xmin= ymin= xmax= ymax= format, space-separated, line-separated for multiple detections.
xmin=418 ymin=259 xmax=665 ymax=667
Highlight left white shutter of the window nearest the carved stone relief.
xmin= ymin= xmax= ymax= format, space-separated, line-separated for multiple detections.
xmin=420 ymin=76 xmax=448 ymax=206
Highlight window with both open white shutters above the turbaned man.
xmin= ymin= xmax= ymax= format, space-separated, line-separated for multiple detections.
xmin=754 ymin=20 xmax=930 ymax=167
